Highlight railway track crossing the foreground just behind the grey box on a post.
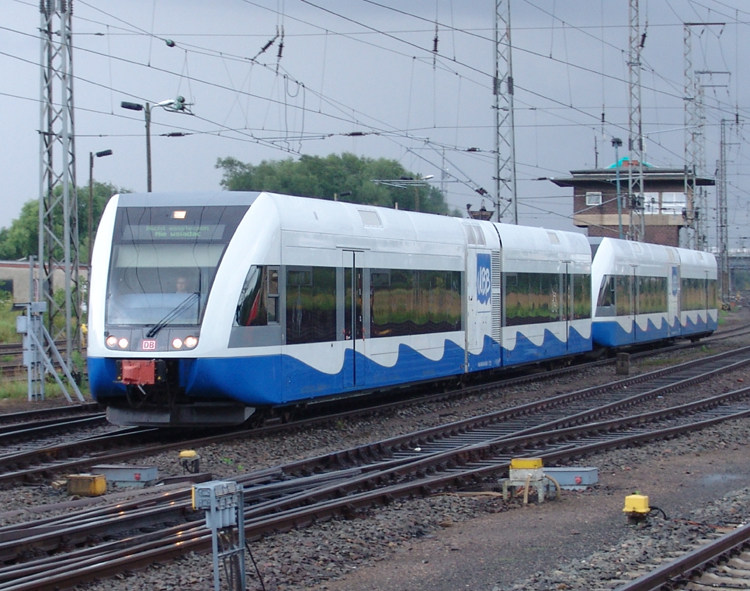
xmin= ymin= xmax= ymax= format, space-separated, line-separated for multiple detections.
xmin=0 ymin=376 xmax=750 ymax=591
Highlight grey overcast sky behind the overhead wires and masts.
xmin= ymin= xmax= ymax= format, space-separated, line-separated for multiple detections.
xmin=0 ymin=0 xmax=750 ymax=246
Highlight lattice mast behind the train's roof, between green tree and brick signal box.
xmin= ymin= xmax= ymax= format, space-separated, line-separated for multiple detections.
xmin=492 ymin=0 xmax=518 ymax=224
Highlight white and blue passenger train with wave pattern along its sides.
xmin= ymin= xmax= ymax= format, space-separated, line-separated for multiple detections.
xmin=87 ymin=191 xmax=718 ymax=427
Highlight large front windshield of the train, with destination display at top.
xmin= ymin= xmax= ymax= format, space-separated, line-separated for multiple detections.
xmin=106 ymin=206 xmax=247 ymax=326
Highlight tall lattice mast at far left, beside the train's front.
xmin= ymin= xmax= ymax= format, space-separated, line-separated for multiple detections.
xmin=39 ymin=0 xmax=81 ymax=366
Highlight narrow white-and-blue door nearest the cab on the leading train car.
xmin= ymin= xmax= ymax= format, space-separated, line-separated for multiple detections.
xmin=342 ymin=250 xmax=366 ymax=388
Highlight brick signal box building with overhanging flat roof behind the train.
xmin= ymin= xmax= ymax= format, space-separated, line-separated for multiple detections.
xmin=550 ymin=158 xmax=715 ymax=246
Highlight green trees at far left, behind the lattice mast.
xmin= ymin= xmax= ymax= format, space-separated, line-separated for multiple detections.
xmin=0 ymin=181 xmax=128 ymax=263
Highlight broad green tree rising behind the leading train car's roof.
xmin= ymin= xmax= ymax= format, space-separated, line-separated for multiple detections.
xmin=216 ymin=153 xmax=458 ymax=215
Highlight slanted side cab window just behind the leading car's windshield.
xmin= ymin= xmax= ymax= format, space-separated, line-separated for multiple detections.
xmin=234 ymin=265 xmax=279 ymax=326
